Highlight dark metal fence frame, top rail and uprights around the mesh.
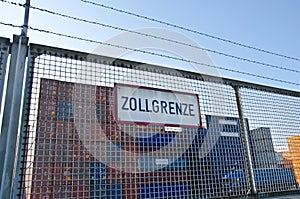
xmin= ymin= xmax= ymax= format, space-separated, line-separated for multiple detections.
xmin=0 ymin=38 xmax=300 ymax=198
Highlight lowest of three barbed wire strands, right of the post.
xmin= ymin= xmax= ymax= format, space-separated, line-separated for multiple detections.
xmin=28 ymin=26 xmax=300 ymax=86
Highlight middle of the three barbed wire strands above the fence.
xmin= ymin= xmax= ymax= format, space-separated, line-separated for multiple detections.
xmin=0 ymin=0 xmax=300 ymax=73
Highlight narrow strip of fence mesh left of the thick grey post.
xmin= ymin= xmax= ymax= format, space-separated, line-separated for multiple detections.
xmin=0 ymin=37 xmax=10 ymax=112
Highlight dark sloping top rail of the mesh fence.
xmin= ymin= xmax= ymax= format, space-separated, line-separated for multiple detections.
xmin=28 ymin=42 xmax=300 ymax=97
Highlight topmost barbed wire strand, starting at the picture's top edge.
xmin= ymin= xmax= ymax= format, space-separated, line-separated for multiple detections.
xmin=80 ymin=0 xmax=300 ymax=61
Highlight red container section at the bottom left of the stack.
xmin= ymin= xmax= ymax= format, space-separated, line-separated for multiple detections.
xmin=31 ymin=161 xmax=89 ymax=198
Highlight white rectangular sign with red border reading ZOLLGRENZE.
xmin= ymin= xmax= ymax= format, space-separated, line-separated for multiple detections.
xmin=115 ymin=84 xmax=200 ymax=127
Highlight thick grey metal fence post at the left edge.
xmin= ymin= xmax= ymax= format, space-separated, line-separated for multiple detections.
xmin=0 ymin=35 xmax=28 ymax=198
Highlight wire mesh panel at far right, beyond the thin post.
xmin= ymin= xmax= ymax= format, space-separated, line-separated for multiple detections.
xmin=241 ymin=88 xmax=300 ymax=192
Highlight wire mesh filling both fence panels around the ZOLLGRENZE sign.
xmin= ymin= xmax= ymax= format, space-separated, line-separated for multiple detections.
xmin=20 ymin=45 xmax=299 ymax=198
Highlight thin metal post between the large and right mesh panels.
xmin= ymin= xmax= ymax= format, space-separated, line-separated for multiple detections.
xmin=233 ymin=85 xmax=257 ymax=194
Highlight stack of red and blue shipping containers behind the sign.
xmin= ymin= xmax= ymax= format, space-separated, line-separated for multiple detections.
xmin=31 ymin=79 xmax=276 ymax=199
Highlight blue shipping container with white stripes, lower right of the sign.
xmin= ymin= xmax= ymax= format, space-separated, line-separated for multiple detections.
xmin=185 ymin=115 xmax=249 ymax=198
